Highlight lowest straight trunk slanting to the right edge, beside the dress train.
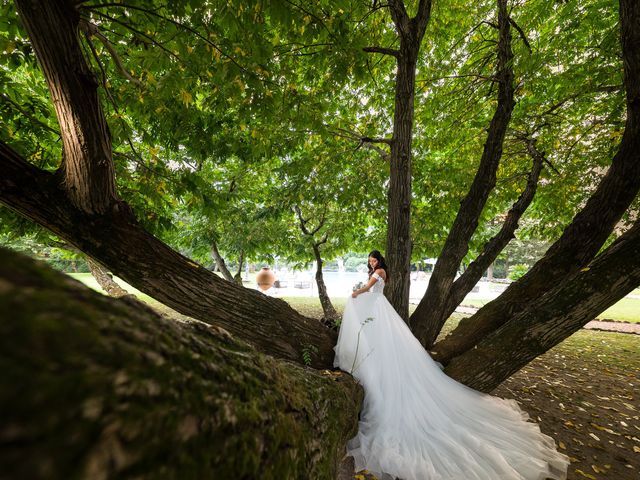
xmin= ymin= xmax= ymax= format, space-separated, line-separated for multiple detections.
xmin=445 ymin=221 xmax=640 ymax=391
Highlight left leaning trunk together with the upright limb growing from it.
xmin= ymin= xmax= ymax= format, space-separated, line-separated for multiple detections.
xmin=0 ymin=0 xmax=335 ymax=367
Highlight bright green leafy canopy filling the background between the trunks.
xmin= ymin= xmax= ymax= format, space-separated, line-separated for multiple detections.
xmin=0 ymin=0 xmax=628 ymax=268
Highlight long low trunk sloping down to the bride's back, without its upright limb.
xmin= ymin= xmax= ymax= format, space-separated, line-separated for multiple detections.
xmin=0 ymin=142 xmax=336 ymax=368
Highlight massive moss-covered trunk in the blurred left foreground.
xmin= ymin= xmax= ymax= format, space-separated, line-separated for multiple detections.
xmin=0 ymin=249 xmax=362 ymax=480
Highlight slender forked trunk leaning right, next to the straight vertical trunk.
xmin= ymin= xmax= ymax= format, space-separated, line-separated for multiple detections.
xmin=411 ymin=0 xmax=520 ymax=348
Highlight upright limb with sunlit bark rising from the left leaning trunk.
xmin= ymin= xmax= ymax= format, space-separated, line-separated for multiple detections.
xmin=16 ymin=0 xmax=117 ymax=214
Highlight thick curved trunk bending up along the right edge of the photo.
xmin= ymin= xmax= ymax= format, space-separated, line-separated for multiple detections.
xmin=434 ymin=0 xmax=640 ymax=363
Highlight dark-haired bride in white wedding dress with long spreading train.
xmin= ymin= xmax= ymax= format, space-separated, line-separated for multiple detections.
xmin=334 ymin=250 xmax=568 ymax=480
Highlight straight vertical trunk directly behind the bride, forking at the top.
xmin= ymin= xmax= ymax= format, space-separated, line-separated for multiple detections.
xmin=385 ymin=0 xmax=431 ymax=321
